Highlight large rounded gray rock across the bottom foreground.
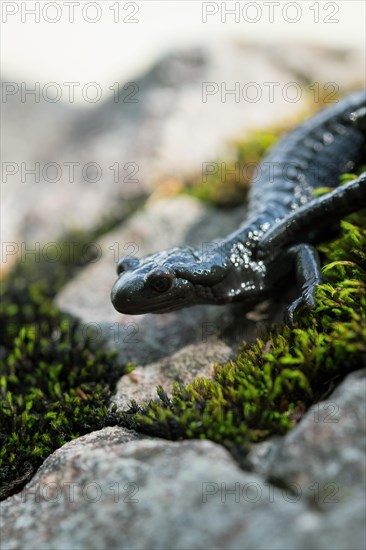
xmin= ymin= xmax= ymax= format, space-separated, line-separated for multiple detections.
xmin=1 ymin=420 xmax=364 ymax=550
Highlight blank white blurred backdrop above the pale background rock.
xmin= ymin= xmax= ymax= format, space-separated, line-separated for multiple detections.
xmin=2 ymin=0 xmax=365 ymax=90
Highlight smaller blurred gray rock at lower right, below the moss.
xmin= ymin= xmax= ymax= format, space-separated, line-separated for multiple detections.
xmin=250 ymin=370 xmax=366 ymax=509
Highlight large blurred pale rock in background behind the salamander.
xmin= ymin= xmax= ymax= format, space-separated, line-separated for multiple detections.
xmin=2 ymin=41 xmax=363 ymax=270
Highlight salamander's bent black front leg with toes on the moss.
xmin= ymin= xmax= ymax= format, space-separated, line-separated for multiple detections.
xmin=285 ymin=244 xmax=322 ymax=326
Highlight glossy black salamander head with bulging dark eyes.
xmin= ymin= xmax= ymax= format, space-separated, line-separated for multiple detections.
xmin=111 ymin=248 xmax=226 ymax=315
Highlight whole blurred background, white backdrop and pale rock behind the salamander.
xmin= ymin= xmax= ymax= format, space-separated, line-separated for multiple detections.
xmin=1 ymin=0 xmax=365 ymax=276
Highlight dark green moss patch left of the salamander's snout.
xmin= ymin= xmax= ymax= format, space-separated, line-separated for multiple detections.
xmin=0 ymin=215 xmax=137 ymax=497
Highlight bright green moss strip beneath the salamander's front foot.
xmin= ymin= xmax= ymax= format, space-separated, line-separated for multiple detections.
xmin=124 ymin=198 xmax=366 ymax=456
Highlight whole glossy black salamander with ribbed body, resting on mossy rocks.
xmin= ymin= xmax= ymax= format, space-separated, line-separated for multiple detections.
xmin=111 ymin=90 xmax=366 ymax=322
